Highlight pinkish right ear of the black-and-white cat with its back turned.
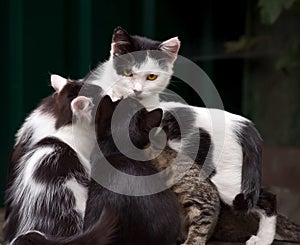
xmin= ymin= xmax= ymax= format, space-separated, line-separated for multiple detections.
xmin=71 ymin=96 xmax=94 ymax=121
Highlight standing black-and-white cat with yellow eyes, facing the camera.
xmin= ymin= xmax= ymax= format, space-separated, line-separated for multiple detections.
xmin=85 ymin=27 xmax=276 ymax=245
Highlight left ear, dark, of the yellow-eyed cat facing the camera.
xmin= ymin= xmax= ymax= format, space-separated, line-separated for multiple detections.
xmin=110 ymin=26 xmax=131 ymax=56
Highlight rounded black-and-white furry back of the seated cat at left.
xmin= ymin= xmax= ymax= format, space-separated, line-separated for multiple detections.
xmin=4 ymin=137 xmax=89 ymax=241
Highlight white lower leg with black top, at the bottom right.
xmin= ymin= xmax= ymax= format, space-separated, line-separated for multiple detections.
xmin=246 ymin=190 xmax=277 ymax=245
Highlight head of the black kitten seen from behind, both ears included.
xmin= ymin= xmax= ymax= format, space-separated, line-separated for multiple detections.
xmin=96 ymin=95 xmax=163 ymax=149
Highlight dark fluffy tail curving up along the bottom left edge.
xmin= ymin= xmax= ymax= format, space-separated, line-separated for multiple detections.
xmin=10 ymin=207 xmax=118 ymax=245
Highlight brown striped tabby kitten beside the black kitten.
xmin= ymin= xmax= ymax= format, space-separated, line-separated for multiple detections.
xmin=154 ymin=146 xmax=220 ymax=245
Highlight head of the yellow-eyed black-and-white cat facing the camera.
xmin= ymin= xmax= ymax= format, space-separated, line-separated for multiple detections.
xmin=111 ymin=27 xmax=180 ymax=99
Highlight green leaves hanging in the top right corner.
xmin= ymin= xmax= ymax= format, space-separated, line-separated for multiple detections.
xmin=258 ymin=0 xmax=297 ymax=25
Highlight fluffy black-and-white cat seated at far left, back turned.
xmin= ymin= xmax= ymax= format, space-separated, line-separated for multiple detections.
xmin=4 ymin=81 xmax=102 ymax=242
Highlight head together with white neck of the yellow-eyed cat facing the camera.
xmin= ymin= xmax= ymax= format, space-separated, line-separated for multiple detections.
xmin=84 ymin=27 xmax=180 ymax=109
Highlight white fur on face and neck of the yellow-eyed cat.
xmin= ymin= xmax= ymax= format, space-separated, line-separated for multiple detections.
xmin=88 ymin=56 xmax=173 ymax=110
